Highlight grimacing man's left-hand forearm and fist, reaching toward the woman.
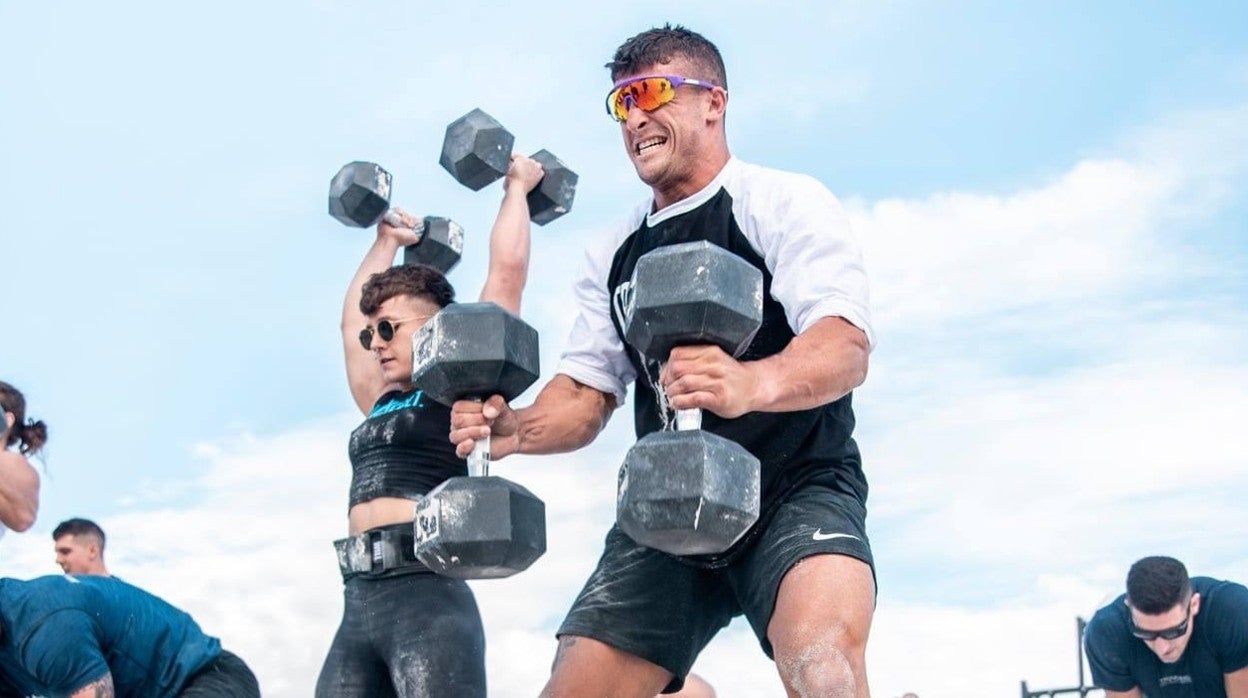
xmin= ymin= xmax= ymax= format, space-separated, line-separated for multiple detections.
xmin=451 ymin=373 xmax=615 ymax=458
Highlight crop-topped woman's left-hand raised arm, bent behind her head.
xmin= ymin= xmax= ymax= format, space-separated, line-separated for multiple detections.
xmin=342 ymin=209 xmax=421 ymax=415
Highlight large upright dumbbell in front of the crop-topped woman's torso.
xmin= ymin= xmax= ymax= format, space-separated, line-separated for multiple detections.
xmin=412 ymin=303 xmax=545 ymax=579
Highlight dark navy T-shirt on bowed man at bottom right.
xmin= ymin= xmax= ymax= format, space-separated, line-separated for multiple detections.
xmin=1086 ymin=577 xmax=1248 ymax=698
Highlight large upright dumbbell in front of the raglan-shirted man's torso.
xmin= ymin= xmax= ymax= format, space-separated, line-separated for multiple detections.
xmin=615 ymin=241 xmax=763 ymax=556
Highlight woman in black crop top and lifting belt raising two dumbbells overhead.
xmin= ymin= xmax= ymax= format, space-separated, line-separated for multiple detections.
xmin=316 ymin=155 xmax=543 ymax=698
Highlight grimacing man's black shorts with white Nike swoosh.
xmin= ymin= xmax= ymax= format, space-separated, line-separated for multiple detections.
xmin=558 ymin=484 xmax=874 ymax=692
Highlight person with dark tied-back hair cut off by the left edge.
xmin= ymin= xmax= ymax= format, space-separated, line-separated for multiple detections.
xmin=0 ymin=381 xmax=47 ymax=538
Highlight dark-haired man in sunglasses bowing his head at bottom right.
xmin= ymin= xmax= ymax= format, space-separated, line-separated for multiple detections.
xmin=1083 ymin=556 xmax=1248 ymax=698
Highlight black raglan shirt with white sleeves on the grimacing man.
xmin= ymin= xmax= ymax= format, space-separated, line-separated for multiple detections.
xmin=558 ymin=159 xmax=875 ymax=561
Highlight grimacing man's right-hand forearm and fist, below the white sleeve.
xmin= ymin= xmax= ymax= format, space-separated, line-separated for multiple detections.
xmin=660 ymin=317 xmax=870 ymax=418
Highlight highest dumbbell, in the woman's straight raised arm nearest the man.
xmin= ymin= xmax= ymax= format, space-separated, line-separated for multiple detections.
xmin=438 ymin=109 xmax=578 ymax=225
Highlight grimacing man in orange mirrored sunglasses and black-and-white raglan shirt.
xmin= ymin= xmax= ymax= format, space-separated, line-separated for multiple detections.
xmin=451 ymin=25 xmax=875 ymax=697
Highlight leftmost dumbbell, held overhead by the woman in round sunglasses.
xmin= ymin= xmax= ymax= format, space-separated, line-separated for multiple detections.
xmin=329 ymin=161 xmax=464 ymax=273
